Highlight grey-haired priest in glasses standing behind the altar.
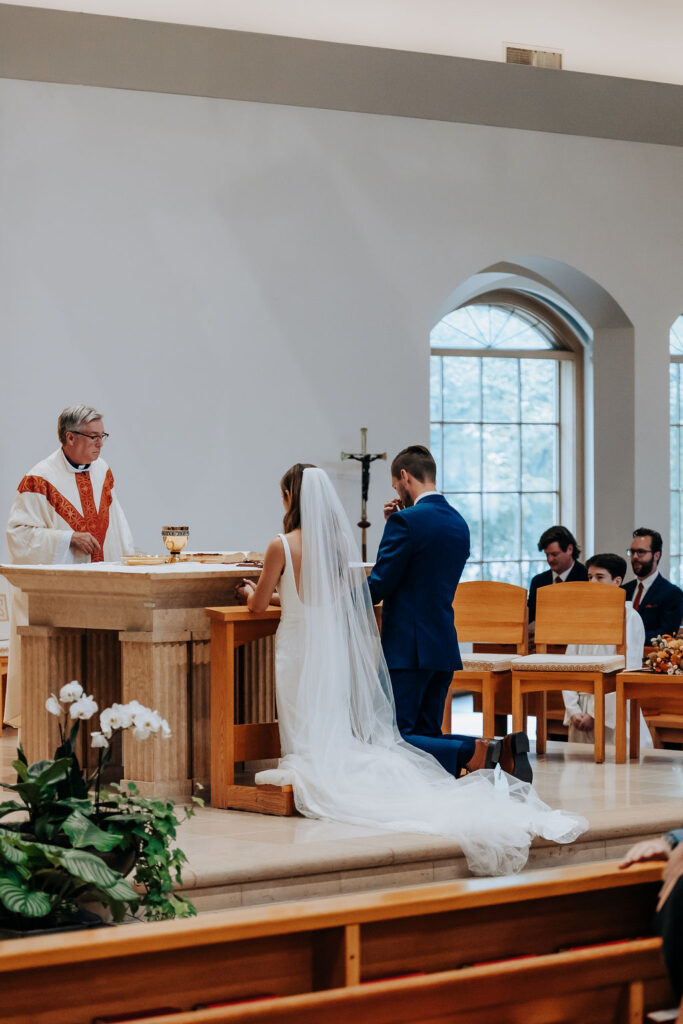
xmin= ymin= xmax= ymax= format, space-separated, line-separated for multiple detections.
xmin=5 ymin=406 xmax=134 ymax=728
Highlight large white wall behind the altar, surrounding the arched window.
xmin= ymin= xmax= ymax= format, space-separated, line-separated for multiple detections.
xmin=0 ymin=80 xmax=683 ymax=555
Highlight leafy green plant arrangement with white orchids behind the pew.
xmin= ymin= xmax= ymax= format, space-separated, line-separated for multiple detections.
xmin=0 ymin=681 xmax=202 ymax=934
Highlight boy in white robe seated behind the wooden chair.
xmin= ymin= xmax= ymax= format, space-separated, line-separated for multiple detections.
xmin=562 ymin=555 xmax=652 ymax=746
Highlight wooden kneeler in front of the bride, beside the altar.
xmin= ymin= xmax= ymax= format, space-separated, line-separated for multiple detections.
xmin=205 ymin=605 xmax=295 ymax=815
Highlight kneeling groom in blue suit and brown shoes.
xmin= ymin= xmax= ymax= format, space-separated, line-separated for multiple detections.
xmin=369 ymin=444 xmax=531 ymax=782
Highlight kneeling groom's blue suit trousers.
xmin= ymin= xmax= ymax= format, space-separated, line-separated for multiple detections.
xmin=389 ymin=669 xmax=475 ymax=778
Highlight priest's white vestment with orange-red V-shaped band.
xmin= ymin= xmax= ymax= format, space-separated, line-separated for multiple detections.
xmin=5 ymin=447 xmax=134 ymax=728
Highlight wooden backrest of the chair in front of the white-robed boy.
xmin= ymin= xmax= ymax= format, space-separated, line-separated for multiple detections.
xmin=536 ymin=583 xmax=626 ymax=654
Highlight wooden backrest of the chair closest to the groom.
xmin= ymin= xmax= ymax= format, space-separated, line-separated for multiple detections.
xmin=453 ymin=580 xmax=528 ymax=654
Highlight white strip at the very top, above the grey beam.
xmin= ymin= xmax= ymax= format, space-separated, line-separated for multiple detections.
xmin=5 ymin=0 xmax=683 ymax=84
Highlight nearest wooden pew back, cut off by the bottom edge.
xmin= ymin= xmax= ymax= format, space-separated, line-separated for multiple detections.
xmin=108 ymin=938 xmax=671 ymax=1024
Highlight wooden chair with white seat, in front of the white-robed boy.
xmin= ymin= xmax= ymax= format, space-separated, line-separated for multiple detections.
xmin=512 ymin=583 xmax=626 ymax=763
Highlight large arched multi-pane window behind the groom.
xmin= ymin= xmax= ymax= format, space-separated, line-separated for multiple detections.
xmin=430 ymin=299 xmax=581 ymax=586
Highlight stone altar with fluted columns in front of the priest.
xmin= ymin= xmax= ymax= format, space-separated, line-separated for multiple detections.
xmin=0 ymin=562 xmax=274 ymax=797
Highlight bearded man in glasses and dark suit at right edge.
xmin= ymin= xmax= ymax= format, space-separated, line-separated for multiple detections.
xmin=624 ymin=526 xmax=683 ymax=643
